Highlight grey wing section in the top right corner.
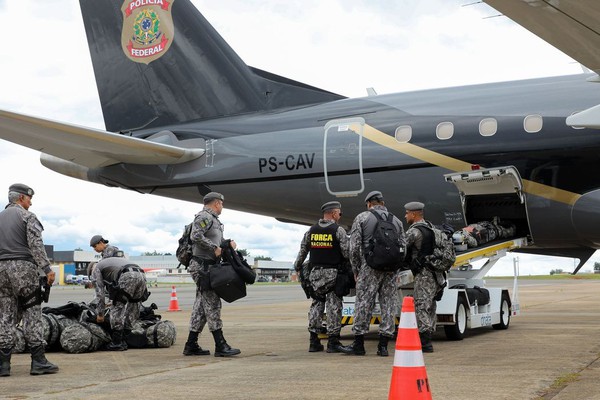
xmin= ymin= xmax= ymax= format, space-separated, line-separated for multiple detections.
xmin=484 ymin=0 xmax=600 ymax=74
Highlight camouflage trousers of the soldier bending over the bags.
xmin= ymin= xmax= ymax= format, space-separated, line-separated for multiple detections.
xmin=110 ymin=271 xmax=146 ymax=331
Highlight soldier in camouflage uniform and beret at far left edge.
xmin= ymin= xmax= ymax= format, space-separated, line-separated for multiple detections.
xmin=0 ymin=183 xmax=58 ymax=376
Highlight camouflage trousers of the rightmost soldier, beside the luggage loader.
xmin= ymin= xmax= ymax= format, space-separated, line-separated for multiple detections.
xmin=413 ymin=268 xmax=440 ymax=333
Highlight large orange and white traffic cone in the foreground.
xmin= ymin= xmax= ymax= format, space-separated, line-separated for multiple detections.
xmin=388 ymin=296 xmax=431 ymax=400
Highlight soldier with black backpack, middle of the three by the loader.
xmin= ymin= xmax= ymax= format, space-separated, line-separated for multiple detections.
xmin=343 ymin=191 xmax=404 ymax=357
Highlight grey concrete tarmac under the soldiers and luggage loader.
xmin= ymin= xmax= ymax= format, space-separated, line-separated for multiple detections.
xmin=0 ymin=280 xmax=600 ymax=400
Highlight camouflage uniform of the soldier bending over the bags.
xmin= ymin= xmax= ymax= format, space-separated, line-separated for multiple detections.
xmin=92 ymin=257 xmax=147 ymax=331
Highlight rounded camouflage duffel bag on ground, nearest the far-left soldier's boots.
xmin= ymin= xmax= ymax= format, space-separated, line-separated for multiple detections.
xmin=60 ymin=322 xmax=110 ymax=353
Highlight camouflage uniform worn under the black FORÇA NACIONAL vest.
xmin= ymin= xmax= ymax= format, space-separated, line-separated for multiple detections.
xmin=294 ymin=219 xmax=349 ymax=336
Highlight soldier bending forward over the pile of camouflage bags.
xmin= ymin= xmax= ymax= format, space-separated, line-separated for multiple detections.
xmin=91 ymin=257 xmax=149 ymax=351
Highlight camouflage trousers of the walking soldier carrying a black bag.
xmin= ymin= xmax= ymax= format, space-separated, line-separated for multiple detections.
xmin=188 ymin=260 xmax=223 ymax=332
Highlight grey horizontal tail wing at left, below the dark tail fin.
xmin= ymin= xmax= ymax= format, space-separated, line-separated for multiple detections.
xmin=0 ymin=110 xmax=204 ymax=168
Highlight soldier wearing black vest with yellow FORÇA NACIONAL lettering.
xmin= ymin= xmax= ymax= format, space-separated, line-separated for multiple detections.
xmin=294 ymin=201 xmax=348 ymax=353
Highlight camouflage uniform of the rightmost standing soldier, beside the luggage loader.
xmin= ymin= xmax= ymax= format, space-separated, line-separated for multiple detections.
xmin=406 ymin=220 xmax=441 ymax=334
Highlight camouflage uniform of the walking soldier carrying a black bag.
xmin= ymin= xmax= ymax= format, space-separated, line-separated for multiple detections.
xmin=188 ymin=207 xmax=223 ymax=332
